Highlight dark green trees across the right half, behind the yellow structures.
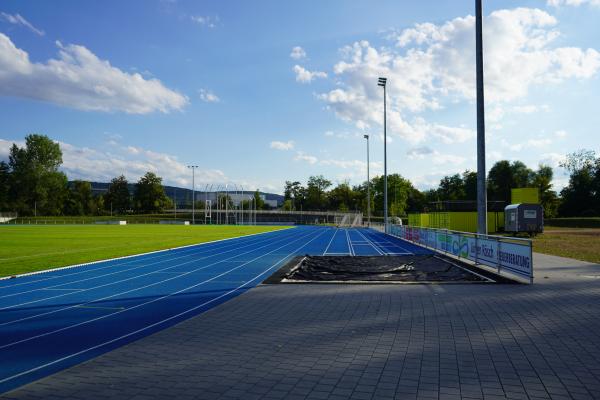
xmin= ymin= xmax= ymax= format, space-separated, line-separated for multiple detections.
xmin=284 ymin=150 xmax=600 ymax=218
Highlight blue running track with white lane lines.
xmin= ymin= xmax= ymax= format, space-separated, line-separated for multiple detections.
xmin=0 ymin=227 xmax=429 ymax=393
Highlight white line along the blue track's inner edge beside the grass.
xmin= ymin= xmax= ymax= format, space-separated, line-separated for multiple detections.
xmin=0 ymin=228 xmax=290 ymax=290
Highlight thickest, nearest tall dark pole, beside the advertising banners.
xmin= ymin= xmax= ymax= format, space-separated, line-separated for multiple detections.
xmin=475 ymin=0 xmax=487 ymax=235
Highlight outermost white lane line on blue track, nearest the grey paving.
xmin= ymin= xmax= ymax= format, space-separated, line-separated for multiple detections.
xmin=0 ymin=231 xmax=325 ymax=384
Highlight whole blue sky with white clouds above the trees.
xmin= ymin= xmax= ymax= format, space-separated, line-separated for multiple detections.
xmin=0 ymin=0 xmax=600 ymax=192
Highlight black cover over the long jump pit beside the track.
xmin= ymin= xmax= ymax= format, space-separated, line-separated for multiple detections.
xmin=265 ymin=255 xmax=494 ymax=283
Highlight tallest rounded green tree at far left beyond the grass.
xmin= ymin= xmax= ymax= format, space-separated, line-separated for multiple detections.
xmin=8 ymin=134 xmax=67 ymax=215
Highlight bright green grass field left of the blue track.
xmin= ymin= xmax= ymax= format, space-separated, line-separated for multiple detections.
xmin=0 ymin=225 xmax=285 ymax=277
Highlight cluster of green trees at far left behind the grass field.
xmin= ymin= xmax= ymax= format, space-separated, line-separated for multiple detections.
xmin=0 ymin=134 xmax=173 ymax=216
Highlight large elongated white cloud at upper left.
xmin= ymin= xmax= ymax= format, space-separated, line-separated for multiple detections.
xmin=0 ymin=33 xmax=188 ymax=114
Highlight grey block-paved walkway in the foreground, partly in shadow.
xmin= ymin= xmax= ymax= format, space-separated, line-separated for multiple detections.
xmin=0 ymin=254 xmax=600 ymax=399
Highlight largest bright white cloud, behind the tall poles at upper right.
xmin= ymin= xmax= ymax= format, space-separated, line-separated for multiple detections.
xmin=318 ymin=8 xmax=600 ymax=143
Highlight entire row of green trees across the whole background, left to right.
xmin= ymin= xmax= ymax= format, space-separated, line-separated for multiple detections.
xmin=0 ymin=134 xmax=600 ymax=217
